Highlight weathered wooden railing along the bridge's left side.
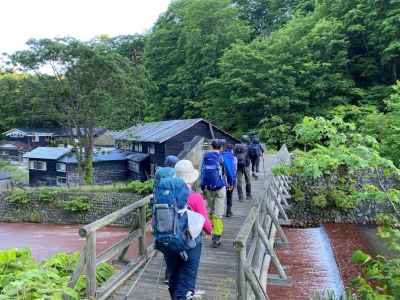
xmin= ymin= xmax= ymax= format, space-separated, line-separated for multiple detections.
xmin=66 ymin=196 xmax=154 ymax=299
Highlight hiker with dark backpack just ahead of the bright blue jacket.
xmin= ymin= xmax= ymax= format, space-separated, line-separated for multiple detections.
xmin=235 ymin=135 xmax=252 ymax=201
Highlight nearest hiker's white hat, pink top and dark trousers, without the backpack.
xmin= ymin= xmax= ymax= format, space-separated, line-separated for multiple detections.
xmin=165 ymin=160 xmax=212 ymax=300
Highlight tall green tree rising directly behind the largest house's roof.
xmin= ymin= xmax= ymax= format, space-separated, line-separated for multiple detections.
xmin=145 ymin=0 xmax=249 ymax=119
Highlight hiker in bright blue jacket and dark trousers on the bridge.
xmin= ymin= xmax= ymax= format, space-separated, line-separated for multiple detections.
xmin=222 ymin=144 xmax=237 ymax=218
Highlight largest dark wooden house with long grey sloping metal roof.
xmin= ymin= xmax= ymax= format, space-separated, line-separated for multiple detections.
xmin=115 ymin=119 xmax=240 ymax=176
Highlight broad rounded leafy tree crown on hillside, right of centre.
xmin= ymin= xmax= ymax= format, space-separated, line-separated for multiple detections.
xmin=208 ymin=14 xmax=354 ymax=139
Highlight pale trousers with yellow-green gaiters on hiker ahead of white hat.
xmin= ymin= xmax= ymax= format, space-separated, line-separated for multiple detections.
xmin=204 ymin=187 xmax=226 ymax=236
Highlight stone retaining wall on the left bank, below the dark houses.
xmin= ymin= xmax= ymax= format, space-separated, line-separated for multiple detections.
xmin=0 ymin=192 xmax=142 ymax=225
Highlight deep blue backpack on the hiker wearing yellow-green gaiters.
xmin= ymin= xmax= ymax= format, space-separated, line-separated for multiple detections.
xmin=200 ymin=151 xmax=225 ymax=191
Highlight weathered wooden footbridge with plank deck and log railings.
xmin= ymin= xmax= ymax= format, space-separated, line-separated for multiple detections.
xmin=70 ymin=146 xmax=290 ymax=300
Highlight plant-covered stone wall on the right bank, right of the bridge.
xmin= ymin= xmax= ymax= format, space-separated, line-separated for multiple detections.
xmin=287 ymin=171 xmax=400 ymax=227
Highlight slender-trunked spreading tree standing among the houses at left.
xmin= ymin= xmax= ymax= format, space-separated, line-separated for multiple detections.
xmin=11 ymin=38 xmax=152 ymax=184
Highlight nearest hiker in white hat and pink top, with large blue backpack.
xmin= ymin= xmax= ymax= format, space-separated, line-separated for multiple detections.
xmin=153 ymin=160 xmax=212 ymax=300
